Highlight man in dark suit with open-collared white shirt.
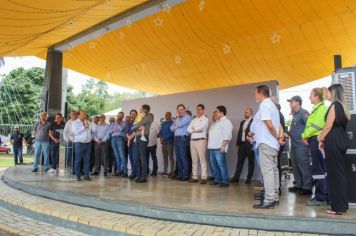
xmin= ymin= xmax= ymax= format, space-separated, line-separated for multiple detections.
xmin=230 ymin=108 xmax=255 ymax=184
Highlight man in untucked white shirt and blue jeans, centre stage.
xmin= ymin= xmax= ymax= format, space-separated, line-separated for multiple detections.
xmin=208 ymin=106 xmax=233 ymax=187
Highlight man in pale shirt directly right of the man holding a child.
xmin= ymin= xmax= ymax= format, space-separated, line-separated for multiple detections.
xmin=147 ymin=114 xmax=161 ymax=176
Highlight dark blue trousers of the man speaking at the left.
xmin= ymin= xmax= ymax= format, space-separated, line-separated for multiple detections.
xmin=74 ymin=143 xmax=91 ymax=178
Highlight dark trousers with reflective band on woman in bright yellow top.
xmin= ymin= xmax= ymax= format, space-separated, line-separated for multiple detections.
xmin=309 ymin=136 xmax=329 ymax=202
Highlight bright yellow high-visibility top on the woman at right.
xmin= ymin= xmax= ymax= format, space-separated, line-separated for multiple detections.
xmin=302 ymin=102 xmax=328 ymax=139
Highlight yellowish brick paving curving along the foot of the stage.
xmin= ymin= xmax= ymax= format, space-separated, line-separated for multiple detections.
xmin=0 ymin=172 xmax=324 ymax=236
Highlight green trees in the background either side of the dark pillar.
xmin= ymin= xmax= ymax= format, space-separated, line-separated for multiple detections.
xmin=0 ymin=67 xmax=145 ymax=124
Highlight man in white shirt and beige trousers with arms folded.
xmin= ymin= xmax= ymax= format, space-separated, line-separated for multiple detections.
xmin=187 ymin=104 xmax=209 ymax=184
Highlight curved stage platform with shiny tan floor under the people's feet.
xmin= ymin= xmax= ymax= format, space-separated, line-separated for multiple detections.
xmin=3 ymin=166 xmax=356 ymax=235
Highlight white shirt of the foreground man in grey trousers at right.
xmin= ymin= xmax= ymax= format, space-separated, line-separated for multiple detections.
xmin=252 ymin=98 xmax=280 ymax=150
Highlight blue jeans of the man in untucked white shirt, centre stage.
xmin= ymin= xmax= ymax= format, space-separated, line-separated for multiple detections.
xmin=210 ymin=149 xmax=229 ymax=184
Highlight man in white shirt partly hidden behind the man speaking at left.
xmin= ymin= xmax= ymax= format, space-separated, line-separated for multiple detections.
xmin=63 ymin=111 xmax=78 ymax=171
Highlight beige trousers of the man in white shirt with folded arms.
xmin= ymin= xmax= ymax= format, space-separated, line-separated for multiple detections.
xmin=190 ymin=139 xmax=208 ymax=180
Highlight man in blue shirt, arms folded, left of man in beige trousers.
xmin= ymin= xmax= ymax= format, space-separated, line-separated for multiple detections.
xmin=171 ymin=104 xmax=192 ymax=181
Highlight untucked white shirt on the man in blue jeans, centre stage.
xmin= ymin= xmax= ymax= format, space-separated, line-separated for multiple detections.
xmin=208 ymin=116 xmax=233 ymax=152
